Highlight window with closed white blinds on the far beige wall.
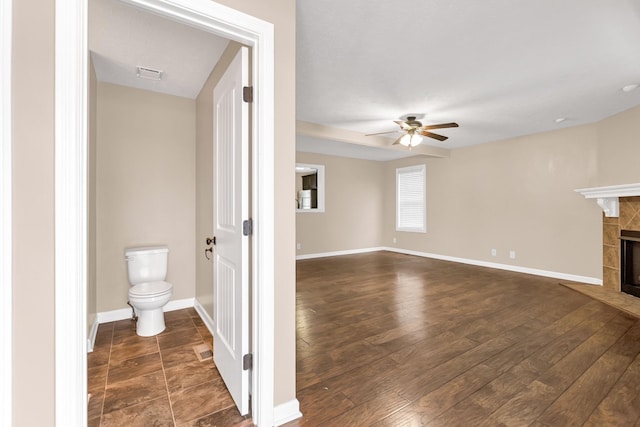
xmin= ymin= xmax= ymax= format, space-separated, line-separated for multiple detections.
xmin=396 ymin=165 xmax=427 ymax=233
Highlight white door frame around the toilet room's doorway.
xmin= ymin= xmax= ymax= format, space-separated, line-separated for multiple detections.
xmin=55 ymin=0 xmax=275 ymax=426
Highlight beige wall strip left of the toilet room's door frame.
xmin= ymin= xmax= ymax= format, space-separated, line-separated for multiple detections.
xmin=12 ymin=0 xmax=55 ymax=426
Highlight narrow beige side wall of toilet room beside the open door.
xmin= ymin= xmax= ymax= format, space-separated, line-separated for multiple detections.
xmin=195 ymin=42 xmax=240 ymax=319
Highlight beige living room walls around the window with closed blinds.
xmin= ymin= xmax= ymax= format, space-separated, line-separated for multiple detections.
xmin=296 ymin=121 xmax=608 ymax=278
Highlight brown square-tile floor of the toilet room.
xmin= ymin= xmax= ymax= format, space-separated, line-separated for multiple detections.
xmin=87 ymin=308 xmax=252 ymax=427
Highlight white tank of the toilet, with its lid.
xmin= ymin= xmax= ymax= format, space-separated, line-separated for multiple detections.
xmin=124 ymin=246 xmax=169 ymax=285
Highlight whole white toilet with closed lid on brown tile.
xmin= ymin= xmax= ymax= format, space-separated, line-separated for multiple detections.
xmin=124 ymin=246 xmax=173 ymax=337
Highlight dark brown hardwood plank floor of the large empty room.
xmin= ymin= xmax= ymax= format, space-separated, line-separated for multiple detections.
xmin=287 ymin=252 xmax=640 ymax=427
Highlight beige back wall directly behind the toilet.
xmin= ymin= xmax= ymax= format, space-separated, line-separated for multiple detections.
xmin=96 ymin=83 xmax=195 ymax=312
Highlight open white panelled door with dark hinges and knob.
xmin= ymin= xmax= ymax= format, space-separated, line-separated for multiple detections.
xmin=213 ymin=47 xmax=249 ymax=415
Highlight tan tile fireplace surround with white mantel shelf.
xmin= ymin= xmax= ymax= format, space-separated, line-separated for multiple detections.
xmin=576 ymin=183 xmax=640 ymax=291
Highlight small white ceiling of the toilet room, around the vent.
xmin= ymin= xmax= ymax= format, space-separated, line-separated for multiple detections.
xmin=89 ymin=0 xmax=229 ymax=99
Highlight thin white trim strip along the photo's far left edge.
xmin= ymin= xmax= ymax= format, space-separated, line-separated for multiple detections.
xmin=0 ymin=0 xmax=13 ymax=426
